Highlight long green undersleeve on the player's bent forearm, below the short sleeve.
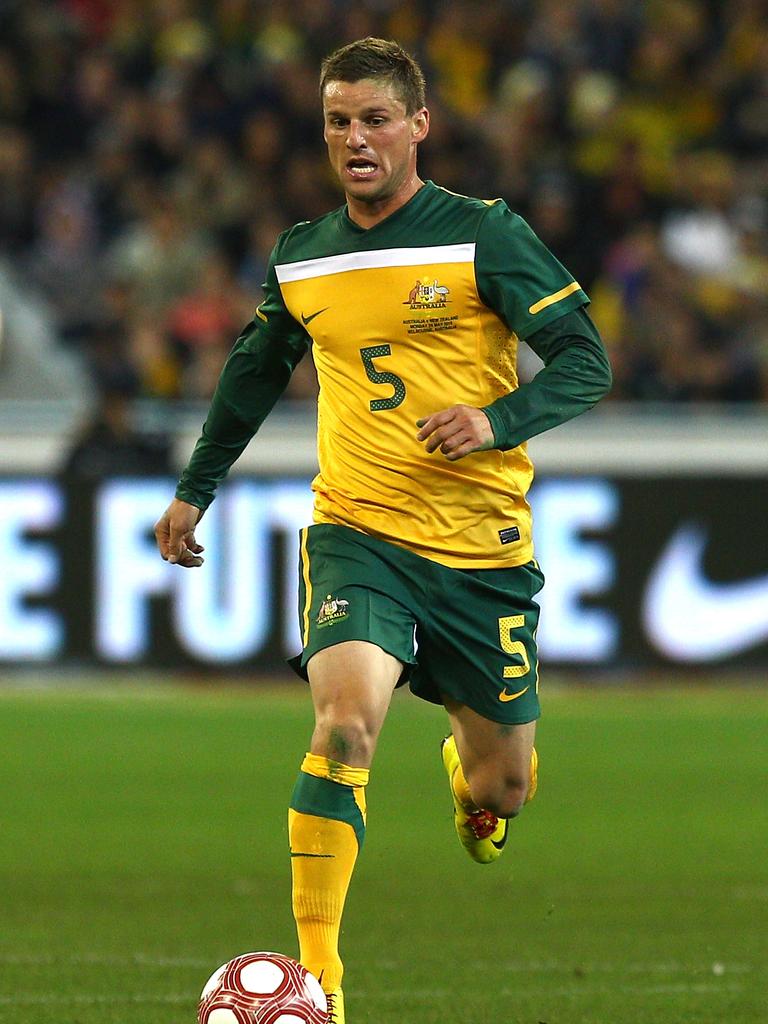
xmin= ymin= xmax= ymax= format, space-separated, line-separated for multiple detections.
xmin=484 ymin=308 xmax=611 ymax=452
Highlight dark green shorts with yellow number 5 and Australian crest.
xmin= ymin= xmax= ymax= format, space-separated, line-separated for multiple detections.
xmin=291 ymin=523 xmax=544 ymax=725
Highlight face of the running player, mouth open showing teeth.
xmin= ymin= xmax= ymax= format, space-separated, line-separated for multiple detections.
xmin=323 ymin=79 xmax=429 ymax=204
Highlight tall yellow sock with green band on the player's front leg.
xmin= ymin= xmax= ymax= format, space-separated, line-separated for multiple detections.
xmin=288 ymin=754 xmax=369 ymax=992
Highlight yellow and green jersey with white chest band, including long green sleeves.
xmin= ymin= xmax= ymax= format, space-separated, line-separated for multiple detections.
xmin=177 ymin=182 xmax=604 ymax=568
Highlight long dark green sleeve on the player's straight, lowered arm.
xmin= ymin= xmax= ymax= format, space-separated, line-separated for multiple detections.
xmin=176 ymin=241 xmax=309 ymax=509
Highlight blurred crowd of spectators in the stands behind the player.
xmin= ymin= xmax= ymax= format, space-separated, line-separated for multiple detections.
xmin=0 ymin=0 xmax=768 ymax=402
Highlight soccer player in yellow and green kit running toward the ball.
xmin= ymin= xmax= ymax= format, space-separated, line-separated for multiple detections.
xmin=156 ymin=39 xmax=610 ymax=1024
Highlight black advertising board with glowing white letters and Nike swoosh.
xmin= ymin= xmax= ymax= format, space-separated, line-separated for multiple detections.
xmin=0 ymin=474 xmax=768 ymax=671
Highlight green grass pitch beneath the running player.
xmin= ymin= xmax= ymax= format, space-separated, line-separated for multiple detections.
xmin=0 ymin=682 xmax=768 ymax=1024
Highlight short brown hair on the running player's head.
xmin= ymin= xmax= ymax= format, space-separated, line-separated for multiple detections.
xmin=321 ymin=36 xmax=426 ymax=115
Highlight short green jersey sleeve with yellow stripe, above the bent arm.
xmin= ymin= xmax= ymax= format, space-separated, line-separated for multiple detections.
xmin=475 ymin=200 xmax=589 ymax=340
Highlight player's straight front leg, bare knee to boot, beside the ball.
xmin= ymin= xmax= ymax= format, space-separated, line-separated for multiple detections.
xmin=289 ymin=640 xmax=402 ymax=1021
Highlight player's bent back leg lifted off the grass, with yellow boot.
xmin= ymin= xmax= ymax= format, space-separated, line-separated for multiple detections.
xmin=442 ymin=696 xmax=538 ymax=863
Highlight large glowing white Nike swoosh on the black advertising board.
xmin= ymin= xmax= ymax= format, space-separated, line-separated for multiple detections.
xmin=643 ymin=523 xmax=768 ymax=662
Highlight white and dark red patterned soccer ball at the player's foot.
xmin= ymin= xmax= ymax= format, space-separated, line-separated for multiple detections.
xmin=198 ymin=952 xmax=330 ymax=1024
